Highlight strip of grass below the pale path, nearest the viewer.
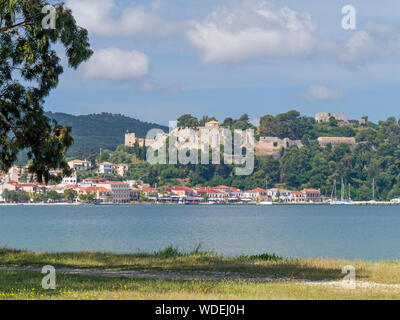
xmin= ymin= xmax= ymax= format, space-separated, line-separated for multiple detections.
xmin=0 ymin=271 xmax=400 ymax=300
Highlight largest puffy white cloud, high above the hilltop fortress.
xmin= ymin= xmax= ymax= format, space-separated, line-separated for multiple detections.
xmin=187 ymin=1 xmax=316 ymax=63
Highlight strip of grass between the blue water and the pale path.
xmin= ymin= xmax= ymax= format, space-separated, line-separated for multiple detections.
xmin=0 ymin=247 xmax=400 ymax=284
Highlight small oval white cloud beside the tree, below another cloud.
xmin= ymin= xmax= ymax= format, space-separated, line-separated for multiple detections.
xmin=84 ymin=48 xmax=150 ymax=80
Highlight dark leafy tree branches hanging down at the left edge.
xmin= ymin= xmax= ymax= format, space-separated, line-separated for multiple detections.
xmin=0 ymin=0 xmax=93 ymax=182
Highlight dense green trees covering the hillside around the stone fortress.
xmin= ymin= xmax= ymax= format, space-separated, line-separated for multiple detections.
xmin=83 ymin=111 xmax=400 ymax=200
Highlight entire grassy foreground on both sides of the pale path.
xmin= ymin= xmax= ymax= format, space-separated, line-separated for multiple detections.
xmin=0 ymin=246 xmax=400 ymax=299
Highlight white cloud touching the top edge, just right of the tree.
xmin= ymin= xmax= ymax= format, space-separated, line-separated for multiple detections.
xmin=67 ymin=0 xmax=179 ymax=37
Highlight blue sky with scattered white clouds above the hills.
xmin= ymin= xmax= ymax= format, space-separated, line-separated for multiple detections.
xmin=45 ymin=0 xmax=400 ymax=125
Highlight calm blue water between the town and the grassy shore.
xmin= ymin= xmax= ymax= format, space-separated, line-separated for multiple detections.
xmin=0 ymin=205 xmax=400 ymax=260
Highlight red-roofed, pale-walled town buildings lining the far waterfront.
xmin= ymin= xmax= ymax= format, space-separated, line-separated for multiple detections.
xmin=0 ymin=160 xmax=327 ymax=204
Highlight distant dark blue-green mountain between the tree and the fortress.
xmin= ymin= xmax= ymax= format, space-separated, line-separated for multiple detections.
xmin=46 ymin=112 xmax=168 ymax=155
